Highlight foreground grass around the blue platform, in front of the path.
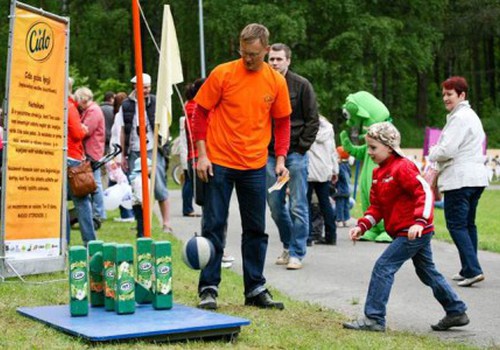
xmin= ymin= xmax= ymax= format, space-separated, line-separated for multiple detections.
xmin=0 ymin=209 xmax=478 ymax=349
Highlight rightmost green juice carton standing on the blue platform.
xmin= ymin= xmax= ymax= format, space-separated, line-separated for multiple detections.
xmin=153 ymin=241 xmax=173 ymax=310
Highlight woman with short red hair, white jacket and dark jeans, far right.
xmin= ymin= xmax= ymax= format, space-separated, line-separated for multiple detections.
xmin=429 ymin=76 xmax=488 ymax=287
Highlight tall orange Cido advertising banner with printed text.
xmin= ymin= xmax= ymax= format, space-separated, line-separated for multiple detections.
xmin=2 ymin=3 xmax=69 ymax=270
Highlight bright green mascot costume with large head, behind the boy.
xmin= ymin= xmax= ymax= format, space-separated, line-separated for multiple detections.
xmin=340 ymin=91 xmax=392 ymax=242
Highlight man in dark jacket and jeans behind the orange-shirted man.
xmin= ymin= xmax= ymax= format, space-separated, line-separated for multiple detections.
xmin=267 ymin=44 xmax=319 ymax=270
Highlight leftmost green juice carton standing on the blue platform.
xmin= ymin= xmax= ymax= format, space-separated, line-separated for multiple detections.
xmin=68 ymin=246 xmax=89 ymax=316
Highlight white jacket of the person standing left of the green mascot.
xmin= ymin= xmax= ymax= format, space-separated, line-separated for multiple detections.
xmin=307 ymin=115 xmax=339 ymax=182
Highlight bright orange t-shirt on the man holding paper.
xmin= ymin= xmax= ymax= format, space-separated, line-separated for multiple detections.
xmin=195 ymin=59 xmax=292 ymax=170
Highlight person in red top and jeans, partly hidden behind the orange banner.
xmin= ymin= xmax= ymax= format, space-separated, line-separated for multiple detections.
xmin=66 ymin=78 xmax=96 ymax=246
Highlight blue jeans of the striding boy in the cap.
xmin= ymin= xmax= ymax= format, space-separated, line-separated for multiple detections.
xmin=365 ymin=233 xmax=467 ymax=326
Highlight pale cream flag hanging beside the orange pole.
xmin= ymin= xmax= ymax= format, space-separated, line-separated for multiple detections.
xmin=155 ymin=5 xmax=184 ymax=144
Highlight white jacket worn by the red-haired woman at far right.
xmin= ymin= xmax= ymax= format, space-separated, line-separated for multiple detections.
xmin=429 ymin=101 xmax=488 ymax=192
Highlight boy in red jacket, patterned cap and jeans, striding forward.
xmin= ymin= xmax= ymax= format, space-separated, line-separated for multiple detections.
xmin=344 ymin=122 xmax=469 ymax=332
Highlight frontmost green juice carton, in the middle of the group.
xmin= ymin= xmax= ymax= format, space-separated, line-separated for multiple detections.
xmin=115 ymin=244 xmax=135 ymax=314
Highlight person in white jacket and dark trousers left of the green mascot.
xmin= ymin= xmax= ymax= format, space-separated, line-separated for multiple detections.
xmin=307 ymin=115 xmax=339 ymax=245
